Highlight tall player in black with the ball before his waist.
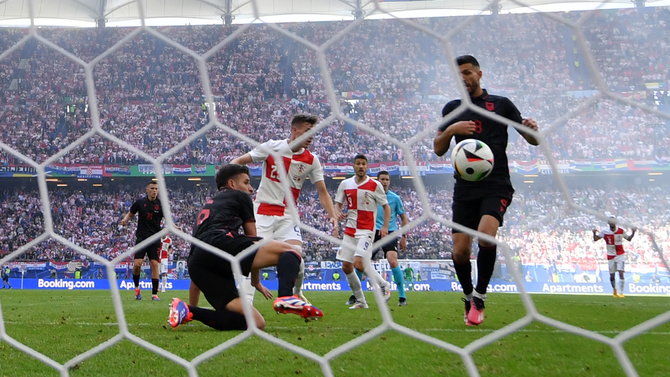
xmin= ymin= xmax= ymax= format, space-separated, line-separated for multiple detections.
xmin=434 ymin=55 xmax=538 ymax=325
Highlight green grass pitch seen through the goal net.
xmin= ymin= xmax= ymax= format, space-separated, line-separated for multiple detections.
xmin=0 ymin=290 xmax=670 ymax=377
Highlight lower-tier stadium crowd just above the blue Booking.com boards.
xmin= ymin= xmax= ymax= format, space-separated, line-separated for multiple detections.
xmin=0 ymin=183 xmax=670 ymax=264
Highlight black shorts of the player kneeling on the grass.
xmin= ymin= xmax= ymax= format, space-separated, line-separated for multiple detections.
xmin=188 ymin=233 xmax=261 ymax=310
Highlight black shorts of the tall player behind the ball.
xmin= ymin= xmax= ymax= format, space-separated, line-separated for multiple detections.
xmin=451 ymin=193 xmax=512 ymax=233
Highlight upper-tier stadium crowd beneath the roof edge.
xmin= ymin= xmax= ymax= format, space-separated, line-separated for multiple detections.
xmin=0 ymin=8 xmax=670 ymax=165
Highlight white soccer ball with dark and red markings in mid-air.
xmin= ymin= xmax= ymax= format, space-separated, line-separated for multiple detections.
xmin=451 ymin=139 xmax=493 ymax=182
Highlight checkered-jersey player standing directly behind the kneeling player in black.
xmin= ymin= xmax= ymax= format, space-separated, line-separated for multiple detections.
xmin=231 ymin=114 xmax=338 ymax=302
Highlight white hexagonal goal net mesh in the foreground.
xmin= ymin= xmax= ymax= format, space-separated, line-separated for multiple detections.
xmin=0 ymin=1 xmax=670 ymax=376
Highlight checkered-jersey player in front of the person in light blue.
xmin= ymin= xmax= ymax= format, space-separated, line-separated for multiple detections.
xmin=335 ymin=154 xmax=391 ymax=309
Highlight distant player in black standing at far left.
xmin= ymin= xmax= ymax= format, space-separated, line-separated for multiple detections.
xmin=121 ymin=181 xmax=163 ymax=301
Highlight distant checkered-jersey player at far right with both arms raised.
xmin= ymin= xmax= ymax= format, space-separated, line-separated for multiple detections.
xmin=593 ymin=217 xmax=637 ymax=298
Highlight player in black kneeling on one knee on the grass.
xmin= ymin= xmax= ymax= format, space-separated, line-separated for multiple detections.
xmin=168 ymin=164 xmax=323 ymax=330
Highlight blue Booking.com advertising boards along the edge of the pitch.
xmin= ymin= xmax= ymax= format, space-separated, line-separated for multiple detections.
xmin=7 ymin=259 xmax=670 ymax=296
